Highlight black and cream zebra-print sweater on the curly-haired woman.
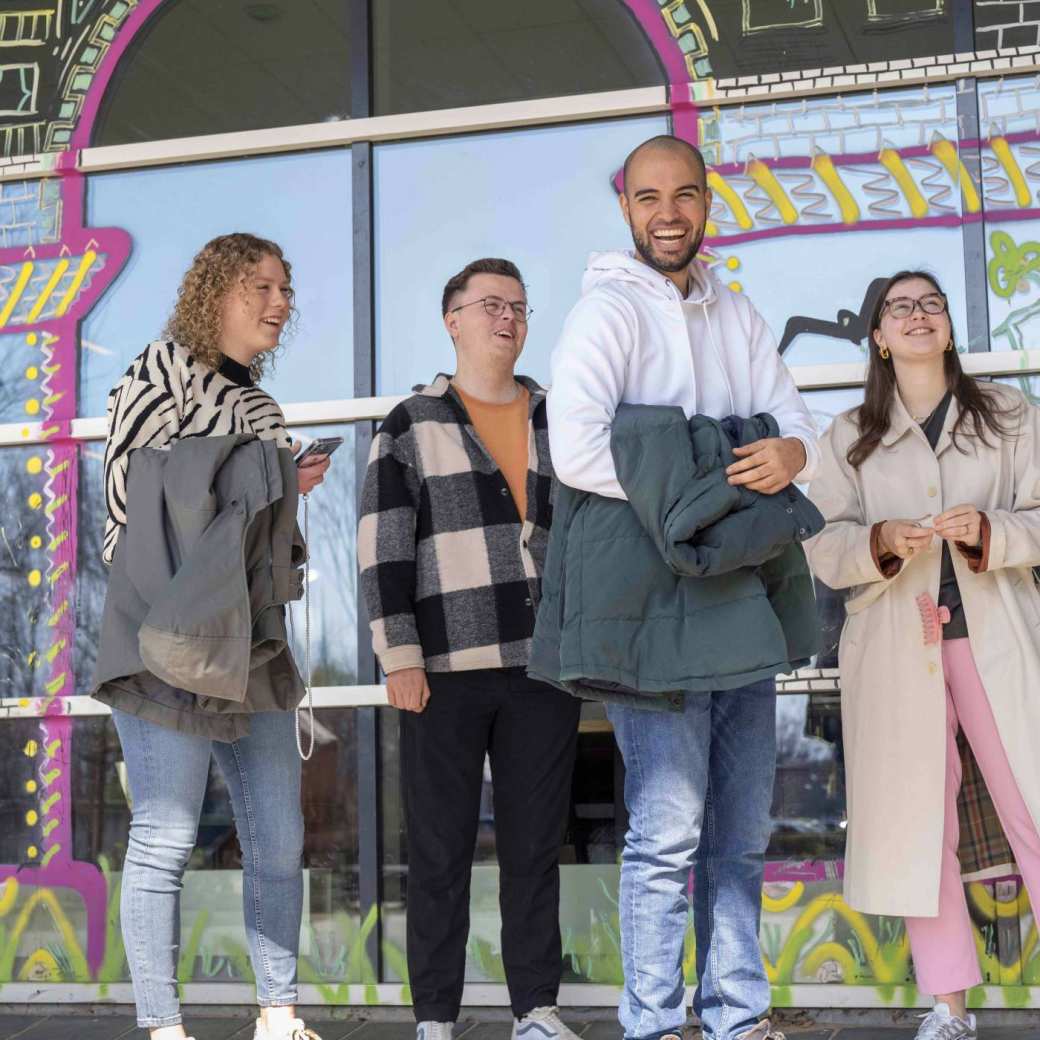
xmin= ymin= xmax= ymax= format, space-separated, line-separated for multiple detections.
xmin=102 ymin=342 xmax=292 ymax=564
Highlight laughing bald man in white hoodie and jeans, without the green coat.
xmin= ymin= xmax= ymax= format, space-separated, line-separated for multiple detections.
xmin=548 ymin=136 xmax=818 ymax=1040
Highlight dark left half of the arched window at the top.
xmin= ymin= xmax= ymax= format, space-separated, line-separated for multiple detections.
xmin=93 ymin=0 xmax=350 ymax=145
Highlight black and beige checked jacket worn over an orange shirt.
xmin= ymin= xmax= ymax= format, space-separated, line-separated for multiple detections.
xmin=358 ymin=375 xmax=552 ymax=673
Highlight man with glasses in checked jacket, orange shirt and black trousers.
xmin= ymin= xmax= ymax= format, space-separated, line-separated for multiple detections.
xmin=358 ymin=259 xmax=579 ymax=1040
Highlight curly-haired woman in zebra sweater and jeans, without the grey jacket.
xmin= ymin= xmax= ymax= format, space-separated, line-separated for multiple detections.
xmin=98 ymin=234 xmax=329 ymax=1040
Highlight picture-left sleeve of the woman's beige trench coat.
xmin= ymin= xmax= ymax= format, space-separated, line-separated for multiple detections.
xmin=805 ymin=416 xmax=898 ymax=589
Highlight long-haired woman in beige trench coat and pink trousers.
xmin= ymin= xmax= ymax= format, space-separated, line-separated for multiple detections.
xmin=806 ymin=271 xmax=1040 ymax=1040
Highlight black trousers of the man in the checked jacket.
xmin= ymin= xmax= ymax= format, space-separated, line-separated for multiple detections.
xmin=401 ymin=669 xmax=580 ymax=1022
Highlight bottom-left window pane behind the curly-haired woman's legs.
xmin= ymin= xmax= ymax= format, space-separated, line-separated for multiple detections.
xmin=0 ymin=708 xmax=361 ymax=985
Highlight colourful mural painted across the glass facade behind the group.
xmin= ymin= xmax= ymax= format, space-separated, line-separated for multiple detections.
xmin=0 ymin=0 xmax=1040 ymax=1006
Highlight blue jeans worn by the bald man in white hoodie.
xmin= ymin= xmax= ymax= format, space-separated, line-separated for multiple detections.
xmin=607 ymin=680 xmax=776 ymax=1040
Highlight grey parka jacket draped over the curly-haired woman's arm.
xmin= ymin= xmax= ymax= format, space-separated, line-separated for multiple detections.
xmin=94 ymin=435 xmax=307 ymax=739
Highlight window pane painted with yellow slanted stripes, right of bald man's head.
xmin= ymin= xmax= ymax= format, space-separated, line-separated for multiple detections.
xmin=702 ymin=84 xmax=965 ymax=365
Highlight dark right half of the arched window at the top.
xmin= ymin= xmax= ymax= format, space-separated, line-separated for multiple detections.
xmin=372 ymin=0 xmax=665 ymax=115
